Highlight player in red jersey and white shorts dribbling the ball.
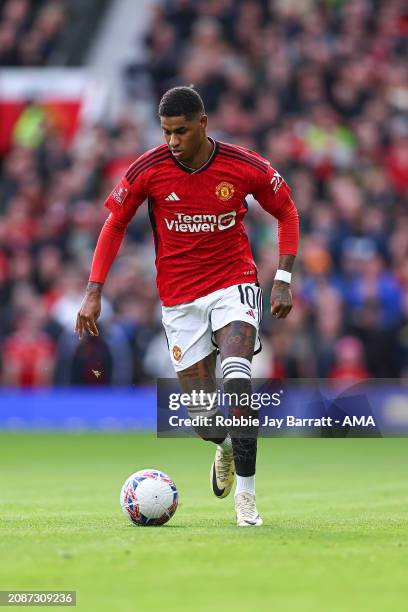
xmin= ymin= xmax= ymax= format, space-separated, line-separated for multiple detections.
xmin=75 ymin=87 xmax=299 ymax=527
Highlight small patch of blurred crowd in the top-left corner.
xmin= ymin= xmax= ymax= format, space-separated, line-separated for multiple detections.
xmin=0 ymin=0 xmax=67 ymax=66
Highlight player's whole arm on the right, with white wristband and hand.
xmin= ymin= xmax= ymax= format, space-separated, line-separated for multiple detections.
xmin=253 ymin=168 xmax=299 ymax=319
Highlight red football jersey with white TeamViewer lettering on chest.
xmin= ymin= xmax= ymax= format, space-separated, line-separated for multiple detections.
xmin=97 ymin=141 xmax=298 ymax=306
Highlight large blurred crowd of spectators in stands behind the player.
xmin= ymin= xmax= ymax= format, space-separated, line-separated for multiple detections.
xmin=0 ymin=0 xmax=408 ymax=385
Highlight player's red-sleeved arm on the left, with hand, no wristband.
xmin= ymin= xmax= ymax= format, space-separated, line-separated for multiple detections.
xmin=75 ymin=171 xmax=146 ymax=338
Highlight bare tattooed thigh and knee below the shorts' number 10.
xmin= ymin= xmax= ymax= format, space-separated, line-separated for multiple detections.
xmin=214 ymin=321 xmax=257 ymax=361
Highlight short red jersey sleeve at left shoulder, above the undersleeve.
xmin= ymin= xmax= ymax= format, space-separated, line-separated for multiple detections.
xmin=105 ymin=166 xmax=147 ymax=224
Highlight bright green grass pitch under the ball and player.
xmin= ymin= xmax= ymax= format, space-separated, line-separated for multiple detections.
xmin=0 ymin=433 xmax=408 ymax=612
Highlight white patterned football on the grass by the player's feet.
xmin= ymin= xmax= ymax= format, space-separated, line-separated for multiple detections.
xmin=120 ymin=470 xmax=179 ymax=526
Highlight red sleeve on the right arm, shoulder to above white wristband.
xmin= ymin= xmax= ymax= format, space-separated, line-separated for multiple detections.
xmin=252 ymin=166 xmax=299 ymax=255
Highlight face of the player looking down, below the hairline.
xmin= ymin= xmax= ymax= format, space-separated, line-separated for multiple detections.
xmin=160 ymin=115 xmax=207 ymax=164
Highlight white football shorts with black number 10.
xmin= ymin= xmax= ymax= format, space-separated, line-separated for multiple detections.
xmin=162 ymin=283 xmax=262 ymax=372
